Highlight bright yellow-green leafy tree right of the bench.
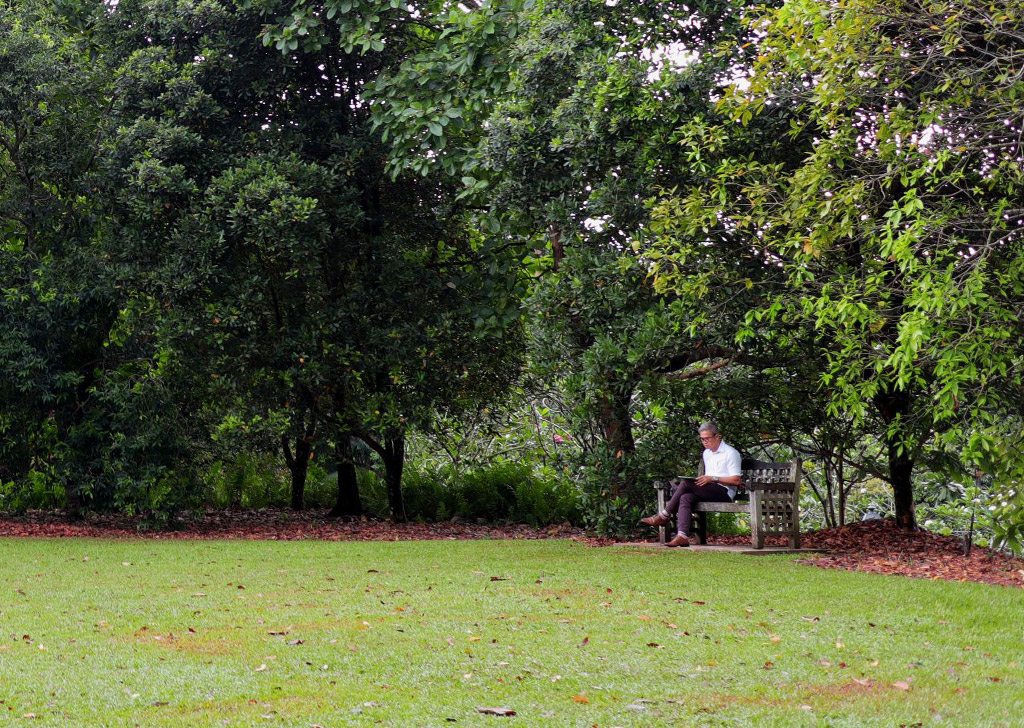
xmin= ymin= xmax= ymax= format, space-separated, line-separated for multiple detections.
xmin=655 ymin=0 xmax=1024 ymax=527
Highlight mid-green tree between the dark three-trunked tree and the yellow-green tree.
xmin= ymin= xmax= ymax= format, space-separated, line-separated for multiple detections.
xmin=473 ymin=0 xmax=815 ymax=532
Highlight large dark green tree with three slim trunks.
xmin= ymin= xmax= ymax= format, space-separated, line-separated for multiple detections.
xmin=96 ymin=0 xmax=515 ymax=519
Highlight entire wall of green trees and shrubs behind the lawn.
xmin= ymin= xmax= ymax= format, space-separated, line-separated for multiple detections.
xmin=0 ymin=0 xmax=1024 ymax=547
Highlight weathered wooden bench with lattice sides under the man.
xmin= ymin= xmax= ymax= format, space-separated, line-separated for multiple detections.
xmin=654 ymin=458 xmax=801 ymax=549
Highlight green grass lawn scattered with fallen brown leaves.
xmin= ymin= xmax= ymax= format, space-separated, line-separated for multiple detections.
xmin=0 ymin=540 xmax=1024 ymax=728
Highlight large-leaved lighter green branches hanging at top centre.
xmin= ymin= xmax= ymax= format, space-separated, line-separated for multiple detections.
xmin=250 ymin=0 xmax=531 ymax=188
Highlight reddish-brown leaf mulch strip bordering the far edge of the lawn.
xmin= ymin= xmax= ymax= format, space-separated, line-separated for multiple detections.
xmin=0 ymin=509 xmax=1024 ymax=588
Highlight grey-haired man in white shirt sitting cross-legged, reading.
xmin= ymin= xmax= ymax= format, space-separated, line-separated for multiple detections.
xmin=640 ymin=422 xmax=743 ymax=547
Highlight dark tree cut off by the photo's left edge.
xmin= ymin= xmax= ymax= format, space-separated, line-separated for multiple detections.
xmin=0 ymin=2 xmax=122 ymax=512
